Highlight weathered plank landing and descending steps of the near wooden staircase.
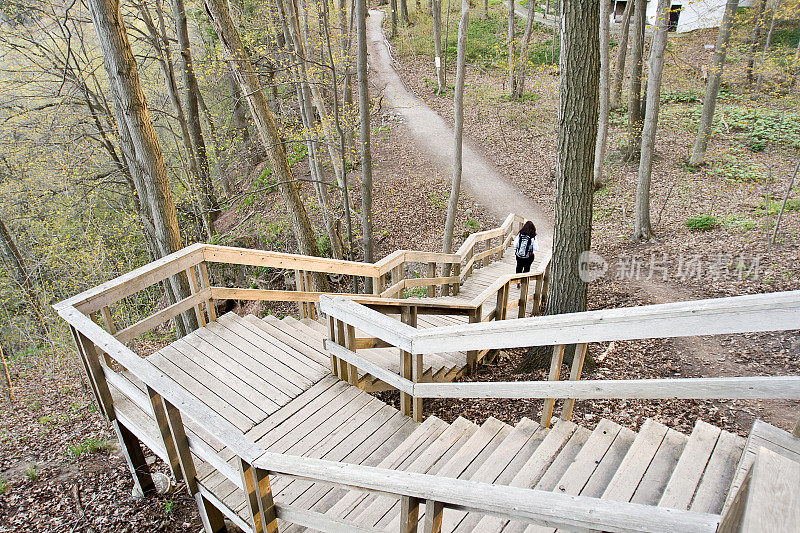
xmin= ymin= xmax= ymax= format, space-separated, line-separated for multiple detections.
xmin=106 ymin=314 xmax=756 ymax=532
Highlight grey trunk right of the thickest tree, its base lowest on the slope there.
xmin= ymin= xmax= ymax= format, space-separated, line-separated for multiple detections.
xmin=633 ymin=0 xmax=672 ymax=241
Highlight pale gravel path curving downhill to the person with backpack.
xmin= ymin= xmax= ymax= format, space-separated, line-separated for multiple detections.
xmin=367 ymin=9 xmax=553 ymax=248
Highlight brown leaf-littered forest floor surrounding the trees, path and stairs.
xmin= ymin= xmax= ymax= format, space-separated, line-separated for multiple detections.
xmin=0 ymin=2 xmax=800 ymax=532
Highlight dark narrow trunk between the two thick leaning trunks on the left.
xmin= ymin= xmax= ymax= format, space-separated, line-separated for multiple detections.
xmin=172 ymin=0 xmax=219 ymax=227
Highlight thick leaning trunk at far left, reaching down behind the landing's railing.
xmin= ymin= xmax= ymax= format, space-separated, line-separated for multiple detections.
xmin=89 ymin=0 xmax=198 ymax=334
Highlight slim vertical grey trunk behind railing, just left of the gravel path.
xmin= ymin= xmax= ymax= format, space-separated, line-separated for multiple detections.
xmin=356 ymin=0 xmax=375 ymax=286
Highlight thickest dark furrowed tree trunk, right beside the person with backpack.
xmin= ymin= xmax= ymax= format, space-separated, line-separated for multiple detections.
xmin=524 ymin=0 xmax=600 ymax=367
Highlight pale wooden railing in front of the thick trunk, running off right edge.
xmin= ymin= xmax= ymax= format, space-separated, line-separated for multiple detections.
xmin=320 ymin=291 xmax=800 ymax=426
